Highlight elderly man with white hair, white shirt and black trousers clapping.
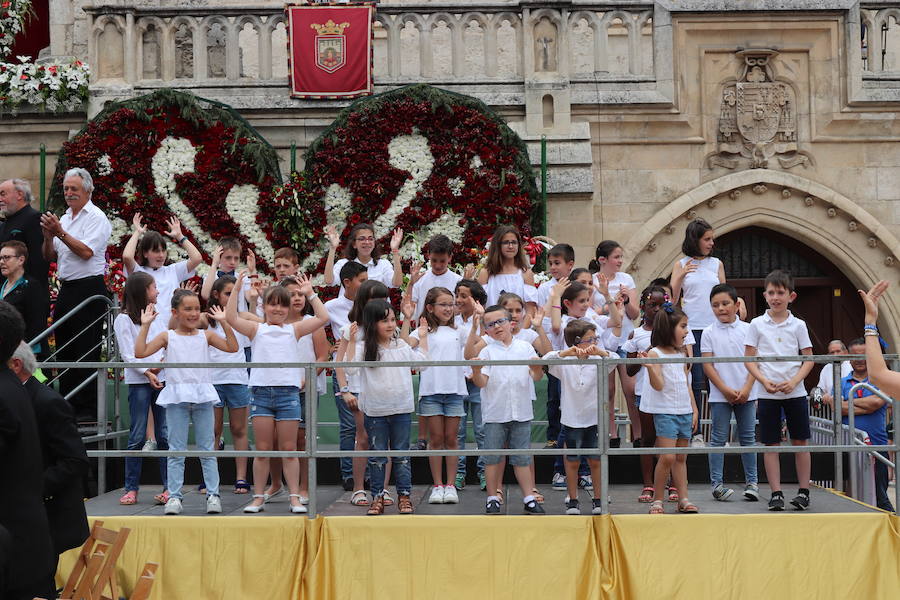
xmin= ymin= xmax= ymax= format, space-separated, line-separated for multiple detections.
xmin=41 ymin=169 xmax=112 ymax=423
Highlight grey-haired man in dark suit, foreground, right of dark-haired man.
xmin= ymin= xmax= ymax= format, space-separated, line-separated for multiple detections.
xmin=9 ymin=342 xmax=90 ymax=568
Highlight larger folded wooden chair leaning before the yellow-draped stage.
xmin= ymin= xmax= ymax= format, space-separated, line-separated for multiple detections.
xmin=60 ymin=521 xmax=131 ymax=600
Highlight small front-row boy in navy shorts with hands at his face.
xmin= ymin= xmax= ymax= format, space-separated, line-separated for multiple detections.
xmin=544 ymin=319 xmax=615 ymax=515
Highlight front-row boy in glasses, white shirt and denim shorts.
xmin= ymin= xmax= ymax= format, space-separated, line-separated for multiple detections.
xmin=469 ymin=305 xmax=544 ymax=515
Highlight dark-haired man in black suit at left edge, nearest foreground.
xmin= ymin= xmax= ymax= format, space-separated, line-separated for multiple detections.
xmin=0 ymin=301 xmax=55 ymax=600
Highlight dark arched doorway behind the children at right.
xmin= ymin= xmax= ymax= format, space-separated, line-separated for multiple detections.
xmin=714 ymin=227 xmax=864 ymax=364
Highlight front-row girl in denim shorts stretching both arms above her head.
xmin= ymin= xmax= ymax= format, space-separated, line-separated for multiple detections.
xmin=225 ymin=272 xmax=328 ymax=513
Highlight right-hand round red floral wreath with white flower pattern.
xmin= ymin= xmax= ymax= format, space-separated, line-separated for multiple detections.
xmin=285 ymin=84 xmax=540 ymax=273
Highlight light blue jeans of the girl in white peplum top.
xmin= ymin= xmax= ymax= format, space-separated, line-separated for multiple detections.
xmin=166 ymin=402 xmax=219 ymax=498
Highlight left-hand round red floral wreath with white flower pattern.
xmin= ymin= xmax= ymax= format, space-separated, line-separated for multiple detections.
xmin=50 ymin=89 xmax=288 ymax=270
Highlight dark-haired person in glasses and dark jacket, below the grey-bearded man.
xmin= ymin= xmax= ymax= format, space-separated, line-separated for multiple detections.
xmin=0 ymin=241 xmax=50 ymax=353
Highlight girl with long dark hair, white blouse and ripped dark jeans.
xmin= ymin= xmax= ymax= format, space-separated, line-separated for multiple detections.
xmin=346 ymin=300 xmax=429 ymax=515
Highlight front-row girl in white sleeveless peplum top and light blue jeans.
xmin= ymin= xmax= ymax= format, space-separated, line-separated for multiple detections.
xmin=134 ymin=289 xmax=238 ymax=515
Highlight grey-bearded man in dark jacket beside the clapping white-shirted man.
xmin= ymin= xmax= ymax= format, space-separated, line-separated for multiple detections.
xmin=0 ymin=179 xmax=50 ymax=287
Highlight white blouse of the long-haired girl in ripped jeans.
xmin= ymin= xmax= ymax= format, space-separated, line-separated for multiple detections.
xmin=347 ymin=339 xmax=428 ymax=417
